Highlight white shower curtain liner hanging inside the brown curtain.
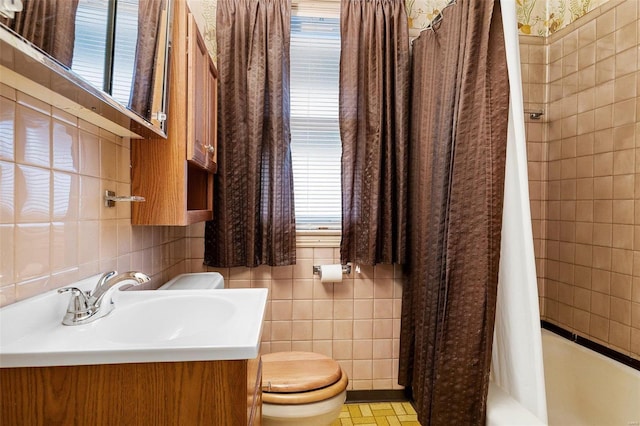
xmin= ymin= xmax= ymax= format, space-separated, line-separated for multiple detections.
xmin=491 ymin=0 xmax=547 ymax=423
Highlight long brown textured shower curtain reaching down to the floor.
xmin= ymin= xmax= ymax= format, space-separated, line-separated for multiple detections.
xmin=399 ymin=0 xmax=509 ymax=425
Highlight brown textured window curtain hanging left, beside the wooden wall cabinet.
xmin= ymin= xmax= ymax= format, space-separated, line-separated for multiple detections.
xmin=205 ymin=0 xmax=296 ymax=267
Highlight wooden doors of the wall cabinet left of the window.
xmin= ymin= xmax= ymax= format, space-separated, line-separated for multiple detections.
xmin=185 ymin=14 xmax=209 ymax=168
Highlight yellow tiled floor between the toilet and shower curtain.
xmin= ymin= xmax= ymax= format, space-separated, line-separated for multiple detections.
xmin=331 ymin=402 xmax=420 ymax=426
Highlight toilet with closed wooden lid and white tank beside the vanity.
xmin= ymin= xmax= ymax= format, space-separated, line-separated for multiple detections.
xmin=158 ymin=272 xmax=349 ymax=426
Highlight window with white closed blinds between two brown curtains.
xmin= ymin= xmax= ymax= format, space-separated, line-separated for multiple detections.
xmin=290 ymin=16 xmax=342 ymax=230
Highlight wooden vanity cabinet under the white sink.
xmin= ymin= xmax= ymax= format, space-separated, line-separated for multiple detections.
xmin=0 ymin=357 xmax=262 ymax=426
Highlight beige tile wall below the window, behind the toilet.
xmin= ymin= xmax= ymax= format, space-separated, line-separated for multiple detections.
xmin=189 ymin=224 xmax=402 ymax=390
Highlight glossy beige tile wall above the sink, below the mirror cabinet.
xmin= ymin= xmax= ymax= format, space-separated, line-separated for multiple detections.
xmin=0 ymin=84 xmax=188 ymax=306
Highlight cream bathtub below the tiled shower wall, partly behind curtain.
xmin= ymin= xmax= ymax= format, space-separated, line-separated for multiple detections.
xmin=487 ymin=330 xmax=640 ymax=426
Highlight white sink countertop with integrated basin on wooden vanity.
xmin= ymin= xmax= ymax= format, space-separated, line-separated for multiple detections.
xmin=0 ymin=276 xmax=267 ymax=367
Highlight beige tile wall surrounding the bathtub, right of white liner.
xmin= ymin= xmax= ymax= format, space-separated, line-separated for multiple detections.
xmin=521 ymin=0 xmax=640 ymax=358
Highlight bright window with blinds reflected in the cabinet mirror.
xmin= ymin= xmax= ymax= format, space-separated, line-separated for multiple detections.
xmin=71 ymin=0 xmax=138 ymax=105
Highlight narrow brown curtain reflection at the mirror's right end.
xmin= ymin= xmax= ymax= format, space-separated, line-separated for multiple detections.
xmin=129 ymin=0 xmax=164 ymax=118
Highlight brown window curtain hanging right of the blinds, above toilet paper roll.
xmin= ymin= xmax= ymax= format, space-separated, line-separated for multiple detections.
xmin=340 ymin=0 xmax=409 ymax=265
